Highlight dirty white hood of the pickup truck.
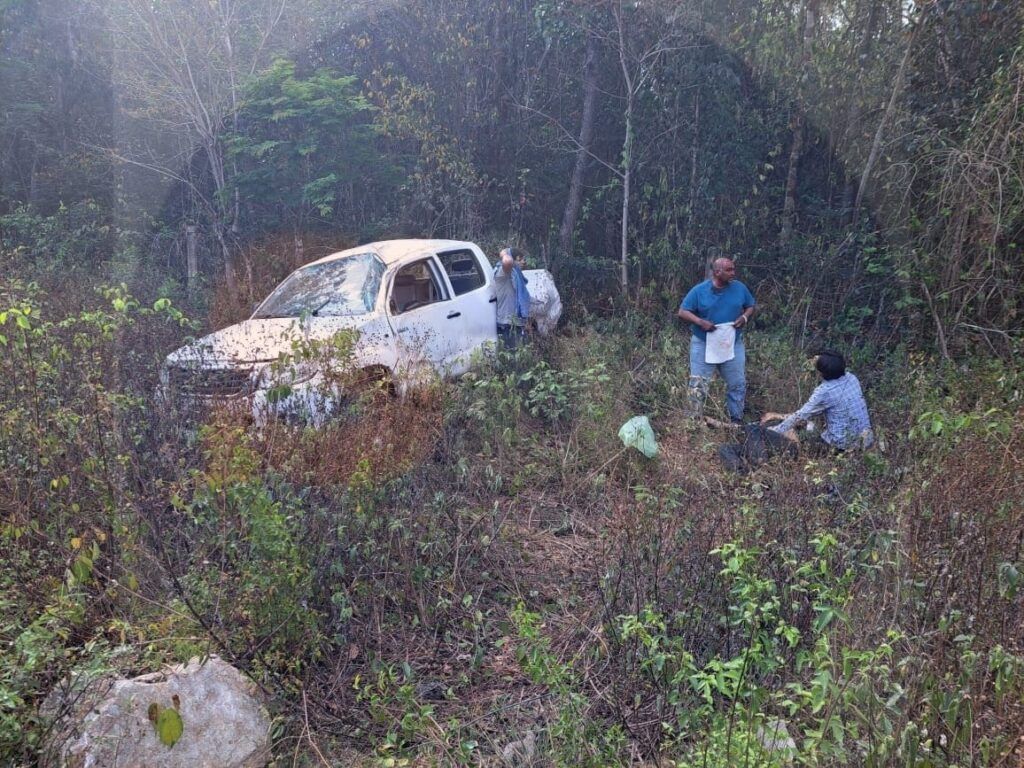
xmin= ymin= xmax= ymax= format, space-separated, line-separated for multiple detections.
xmin=166 ymin=316 xmax=371 ymax=368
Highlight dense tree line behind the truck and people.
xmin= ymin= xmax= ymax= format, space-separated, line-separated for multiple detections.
xmin=0 ymin=0 xmax=1024 ymax=354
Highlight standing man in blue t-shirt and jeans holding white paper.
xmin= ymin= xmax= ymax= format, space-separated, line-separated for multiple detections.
xmin=679 ymin=259 xmax=756 ymax=423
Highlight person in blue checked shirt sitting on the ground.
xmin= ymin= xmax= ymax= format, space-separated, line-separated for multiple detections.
xmin=764 ymin=350 xmax=874 ymax=451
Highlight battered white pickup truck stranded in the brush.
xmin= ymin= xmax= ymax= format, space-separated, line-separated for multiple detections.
xmin=161 ymin=240 xmax=562 ymax=426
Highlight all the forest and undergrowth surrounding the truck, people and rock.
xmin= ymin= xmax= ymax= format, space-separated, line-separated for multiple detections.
xmin=0 ymin=0 xmax=1024 ymax=768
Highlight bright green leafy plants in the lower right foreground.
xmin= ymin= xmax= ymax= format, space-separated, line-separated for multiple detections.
xmin=602 ymin=534 xmax=962 ymax=766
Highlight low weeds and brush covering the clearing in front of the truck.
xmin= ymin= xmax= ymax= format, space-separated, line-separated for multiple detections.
xmin=0 ymin=286 xmax=1024 ymax=766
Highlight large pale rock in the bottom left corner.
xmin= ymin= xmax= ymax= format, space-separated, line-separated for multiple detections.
xmin=43 ymin=656 xmax=270 ymax=768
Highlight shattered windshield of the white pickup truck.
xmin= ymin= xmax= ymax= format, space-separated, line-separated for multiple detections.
xmin=253 ymin=253 xmax=384 ymax=317
